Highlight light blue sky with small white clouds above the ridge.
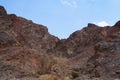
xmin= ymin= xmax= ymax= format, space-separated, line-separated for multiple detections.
xmin=0 ymin=0 xmax=120 ymax=38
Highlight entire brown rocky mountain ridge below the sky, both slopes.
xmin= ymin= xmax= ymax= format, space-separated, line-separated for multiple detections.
xmin=0 ymin=6 xmax=120 ymax=80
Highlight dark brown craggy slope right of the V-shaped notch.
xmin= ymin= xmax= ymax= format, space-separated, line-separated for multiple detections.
xmin=66 ymin=22 xmax=120 ymax=80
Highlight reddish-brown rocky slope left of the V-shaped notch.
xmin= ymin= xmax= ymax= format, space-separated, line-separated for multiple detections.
xmin=0 ymin=6 xmax=59 ymax=80
